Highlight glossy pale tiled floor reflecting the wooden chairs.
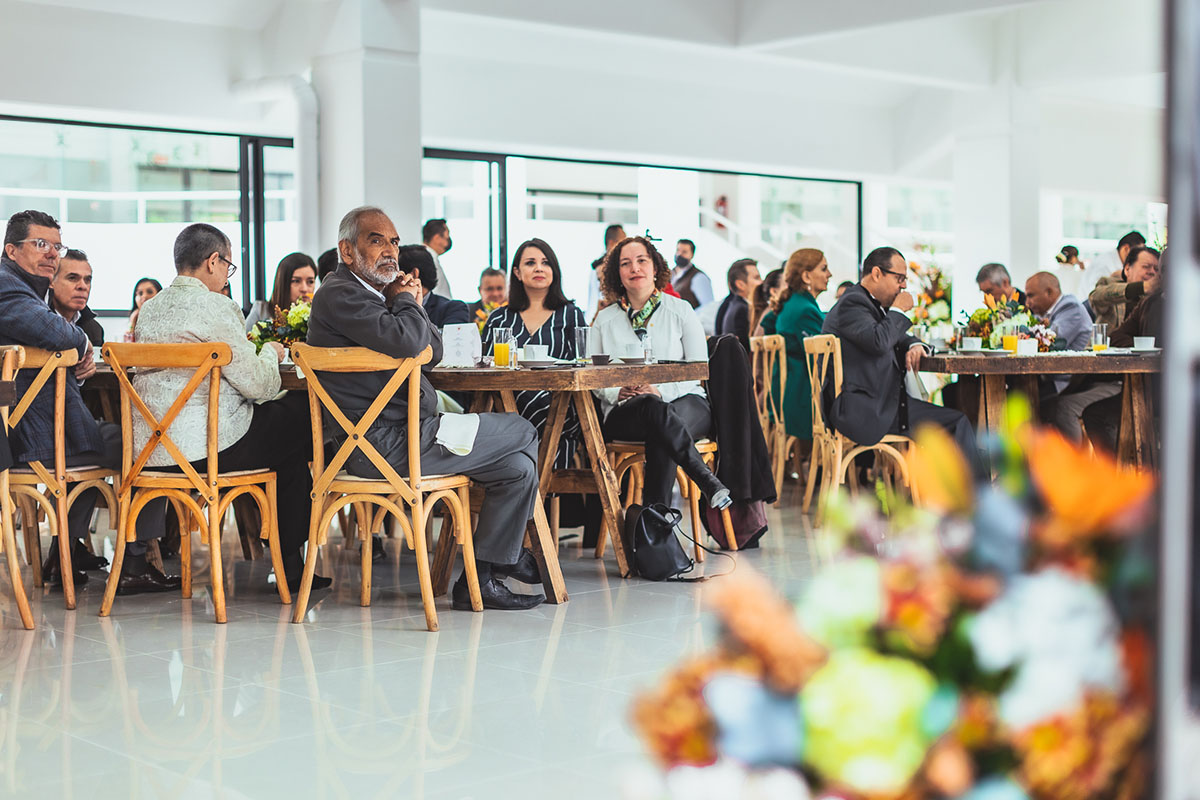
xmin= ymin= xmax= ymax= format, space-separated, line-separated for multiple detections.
xmin=0 ymin=491 xmax=811 ymax=799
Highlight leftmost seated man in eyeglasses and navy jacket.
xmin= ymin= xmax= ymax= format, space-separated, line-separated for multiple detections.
xmin=0 ymin=211 xmax=179 ymax=594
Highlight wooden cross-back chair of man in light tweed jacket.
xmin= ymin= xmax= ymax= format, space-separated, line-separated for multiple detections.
xmin=100 ymin=342 xmax=292 ymax=622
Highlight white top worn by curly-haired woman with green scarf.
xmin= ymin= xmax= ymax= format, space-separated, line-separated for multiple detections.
xmin=592 ymin=294 xmax=708 ymax=419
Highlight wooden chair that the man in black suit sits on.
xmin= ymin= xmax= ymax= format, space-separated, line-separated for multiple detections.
xmin=803 ymin=333 xmax=919 ymax=523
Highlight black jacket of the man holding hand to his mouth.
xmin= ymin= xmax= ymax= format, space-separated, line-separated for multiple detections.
xmin=821 ymin=283 xmax=920 ymax=445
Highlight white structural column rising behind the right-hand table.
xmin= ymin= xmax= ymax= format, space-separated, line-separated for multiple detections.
xmin=953 ymin=18 xmax=1040 ymax=319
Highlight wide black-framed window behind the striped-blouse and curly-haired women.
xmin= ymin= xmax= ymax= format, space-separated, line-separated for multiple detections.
xmin=422 ymin=151 xmax=862 ymax=307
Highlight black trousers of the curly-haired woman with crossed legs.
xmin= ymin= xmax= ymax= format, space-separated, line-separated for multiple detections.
xmin=604 ymin=395 xmax=721 ymax=505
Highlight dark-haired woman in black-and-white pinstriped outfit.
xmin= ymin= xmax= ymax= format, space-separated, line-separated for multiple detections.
xmin=484 ymin=239 xmax=586 ymax=469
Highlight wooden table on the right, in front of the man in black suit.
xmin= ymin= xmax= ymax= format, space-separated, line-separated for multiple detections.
xmin=919 ymin=353 xmax=1163 ymax=467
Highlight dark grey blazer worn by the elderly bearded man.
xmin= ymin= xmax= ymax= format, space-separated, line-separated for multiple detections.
xmin=307 ymin=264 xmax=442 ymax=458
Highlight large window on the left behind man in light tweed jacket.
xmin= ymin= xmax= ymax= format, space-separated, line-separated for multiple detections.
xmin=0 ymin=118 xmax=298 ymax=337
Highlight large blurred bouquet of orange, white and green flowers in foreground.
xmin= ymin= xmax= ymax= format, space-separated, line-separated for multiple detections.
xmin=628 ymin=396 xmax=1154 ymax=800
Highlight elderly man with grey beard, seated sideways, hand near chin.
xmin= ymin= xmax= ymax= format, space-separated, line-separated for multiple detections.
xmin=308 ymin=206 xmax=542 ymax=609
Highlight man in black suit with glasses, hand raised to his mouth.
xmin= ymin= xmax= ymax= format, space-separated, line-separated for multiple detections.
xmin=822 ymin=247 xmax=986 ymax=477
